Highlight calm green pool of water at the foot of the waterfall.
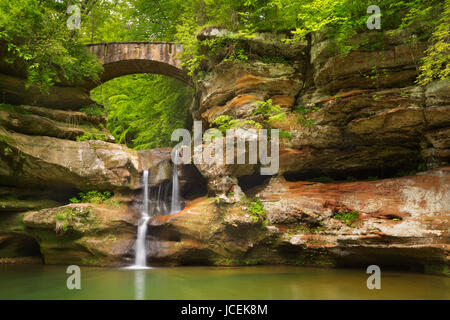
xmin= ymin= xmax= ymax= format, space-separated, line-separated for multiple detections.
xmin=0 ymin=265 xmax=450 ymax=300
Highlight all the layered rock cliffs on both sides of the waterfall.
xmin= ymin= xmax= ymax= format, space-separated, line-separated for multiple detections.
xmin=0 ymin=28 xmax=450 ymax=274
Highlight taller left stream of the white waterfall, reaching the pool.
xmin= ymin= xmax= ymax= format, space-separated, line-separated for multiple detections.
xmin=132 ymin=170 xmax=150 ymax=269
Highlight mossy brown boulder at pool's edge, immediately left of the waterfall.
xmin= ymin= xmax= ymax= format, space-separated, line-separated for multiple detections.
xmin=23 ymin=203 xmax=136 ymax=266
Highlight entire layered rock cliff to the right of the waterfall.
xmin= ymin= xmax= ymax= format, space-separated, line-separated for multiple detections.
xmin=141 ymin=28 xmax=450 ymax=274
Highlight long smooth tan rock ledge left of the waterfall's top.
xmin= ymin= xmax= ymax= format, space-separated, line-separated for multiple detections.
xmin=0 ymin=128 xmax=139 ymax=190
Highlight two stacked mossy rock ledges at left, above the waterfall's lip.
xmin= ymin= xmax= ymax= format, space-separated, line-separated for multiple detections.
xmin=0 ymin=106 xmax=139 ymax=191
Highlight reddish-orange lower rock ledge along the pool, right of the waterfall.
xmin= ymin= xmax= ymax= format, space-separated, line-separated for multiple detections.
xmin=149 ymin=167 xmax=450 ymax=273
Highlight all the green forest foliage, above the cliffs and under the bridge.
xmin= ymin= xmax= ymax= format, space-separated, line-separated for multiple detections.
xmin=0 ymin=0 xmax=450 ymax=148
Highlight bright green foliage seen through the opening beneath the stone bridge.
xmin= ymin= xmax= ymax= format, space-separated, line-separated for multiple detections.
xmin=91 ymin=74 xmax=192 ymax=149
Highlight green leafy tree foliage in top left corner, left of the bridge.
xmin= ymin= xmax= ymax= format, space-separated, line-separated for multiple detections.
xmin=0 ymin=0 xmax=102 ymax=90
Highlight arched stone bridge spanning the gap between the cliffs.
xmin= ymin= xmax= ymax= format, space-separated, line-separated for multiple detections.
xmin=87 ymin=42 xmax=193 ymax=88
